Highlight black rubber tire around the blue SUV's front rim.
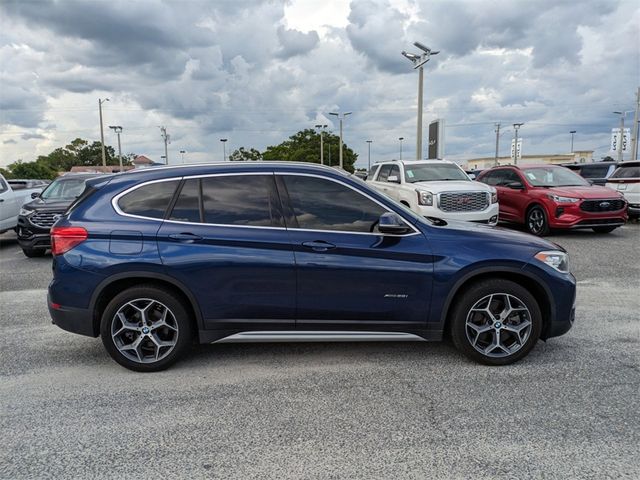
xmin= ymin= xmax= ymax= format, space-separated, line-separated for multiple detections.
xmin=449 ymin=279 xmax=542 ymax=365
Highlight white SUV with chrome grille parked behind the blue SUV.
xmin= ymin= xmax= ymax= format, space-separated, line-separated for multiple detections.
xmin=367 ymin=160 xmax=498 ymax=225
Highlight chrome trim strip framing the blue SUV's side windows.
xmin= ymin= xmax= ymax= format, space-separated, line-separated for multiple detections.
xmin=111 ymin=172 xmax=421 ymax=237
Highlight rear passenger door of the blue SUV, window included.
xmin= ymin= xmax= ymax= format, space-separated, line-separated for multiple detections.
xmin=158 ymin=173 xmax=296 ymax=330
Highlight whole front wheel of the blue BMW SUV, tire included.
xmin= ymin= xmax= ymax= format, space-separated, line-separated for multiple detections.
xmin=450 ymin=279 xmax=542 ymax=365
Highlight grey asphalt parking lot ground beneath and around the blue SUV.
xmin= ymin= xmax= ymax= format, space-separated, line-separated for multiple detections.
xmin=0 ymin=223 xmax=640 ymax=479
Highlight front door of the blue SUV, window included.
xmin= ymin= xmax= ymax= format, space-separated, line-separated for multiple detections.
xmin=276 ymin=173 xmax=433 ymax=331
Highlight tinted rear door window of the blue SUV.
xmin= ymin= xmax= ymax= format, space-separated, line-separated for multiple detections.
xmin=202 ymin=175 xmax=283 ymax=227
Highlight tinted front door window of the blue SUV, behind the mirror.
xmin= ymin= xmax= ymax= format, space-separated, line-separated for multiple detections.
xmin=283 ymin=174 xmax=386 ymax=232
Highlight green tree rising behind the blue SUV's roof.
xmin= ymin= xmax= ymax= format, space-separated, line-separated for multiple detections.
xmin=262 ymin=128 xmax=358 ymax=173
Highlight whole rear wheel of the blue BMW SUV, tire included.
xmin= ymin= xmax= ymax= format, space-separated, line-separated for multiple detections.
xmin=100 ymin=286 xmax=192 ymax=372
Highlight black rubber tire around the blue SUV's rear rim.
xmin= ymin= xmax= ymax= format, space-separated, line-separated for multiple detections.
xmin=100 ymin=285 xmax=193 ymax=372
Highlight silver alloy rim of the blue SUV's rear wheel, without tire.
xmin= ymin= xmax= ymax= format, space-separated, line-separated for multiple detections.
xmin=111 ymin=298 xmax=179 ymax=363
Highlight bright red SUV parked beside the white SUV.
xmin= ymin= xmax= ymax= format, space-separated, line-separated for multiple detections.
xmin=478 ymin=165 xmax=627 ymax=236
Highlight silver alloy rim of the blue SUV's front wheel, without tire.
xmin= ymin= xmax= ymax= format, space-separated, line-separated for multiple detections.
xmin=465 ymin=293 xmax=533 ymax=358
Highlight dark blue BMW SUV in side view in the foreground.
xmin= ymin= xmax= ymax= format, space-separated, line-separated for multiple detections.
xmin=48 ymin=162 xmax=575 ymax=371
